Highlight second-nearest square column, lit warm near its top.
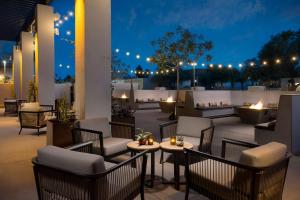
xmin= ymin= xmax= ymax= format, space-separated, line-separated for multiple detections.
xmin=35 ymin=4 xmax=55 ymax=105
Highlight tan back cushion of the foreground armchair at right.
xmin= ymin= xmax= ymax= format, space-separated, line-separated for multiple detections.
xmin=240 ymin=142 xmax=287 ymax=167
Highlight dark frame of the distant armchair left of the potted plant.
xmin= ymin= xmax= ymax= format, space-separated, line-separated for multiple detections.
xmin=19 ymin=105 xmax=54 ymax=135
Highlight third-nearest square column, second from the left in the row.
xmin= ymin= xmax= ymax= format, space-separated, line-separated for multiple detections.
xmin=21 ymin=32 xmax=34 ymax=99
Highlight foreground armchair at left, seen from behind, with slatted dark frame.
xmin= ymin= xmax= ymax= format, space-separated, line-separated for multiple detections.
xmin=33 ymin=142 xmax=147 ymax=200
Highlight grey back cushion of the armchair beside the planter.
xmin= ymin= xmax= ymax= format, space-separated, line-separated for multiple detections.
xmin=79 ymin=117 xmax=111 ymax=138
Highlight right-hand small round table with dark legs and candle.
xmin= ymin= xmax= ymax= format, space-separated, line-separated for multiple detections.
xmin=160 ymin=141 xmax=193 ymax=190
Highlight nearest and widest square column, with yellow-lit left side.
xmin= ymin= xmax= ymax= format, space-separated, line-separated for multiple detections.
xmin=75 ymin=0 xmax=111 ymax=119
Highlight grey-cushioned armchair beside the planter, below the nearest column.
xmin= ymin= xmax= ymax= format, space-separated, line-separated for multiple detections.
xmin=72 ymin=118 xmax=135 ymax=160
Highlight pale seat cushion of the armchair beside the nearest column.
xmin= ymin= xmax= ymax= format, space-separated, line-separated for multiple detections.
xmin=93 ymin=137 xmax=132 ymax=156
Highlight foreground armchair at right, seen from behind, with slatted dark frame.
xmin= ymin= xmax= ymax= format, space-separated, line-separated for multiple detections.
xmin=185 ymin=139 xmax=290 ymax=200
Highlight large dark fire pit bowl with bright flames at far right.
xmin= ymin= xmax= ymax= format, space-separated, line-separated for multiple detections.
xmin=238 ymin=101 xmax=272 ymax=124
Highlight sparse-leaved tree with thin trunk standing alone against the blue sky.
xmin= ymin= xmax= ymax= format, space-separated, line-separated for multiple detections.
xmin=150 ymin=26 xmax=213 ymax=100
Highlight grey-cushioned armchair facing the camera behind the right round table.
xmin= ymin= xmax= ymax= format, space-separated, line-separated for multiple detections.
xmin=160 ymin=116 xmax=214 ymax=154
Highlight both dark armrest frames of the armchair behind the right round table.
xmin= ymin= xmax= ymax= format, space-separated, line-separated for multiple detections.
xmin=159 ymin=120 xmax=215 ymax=154
